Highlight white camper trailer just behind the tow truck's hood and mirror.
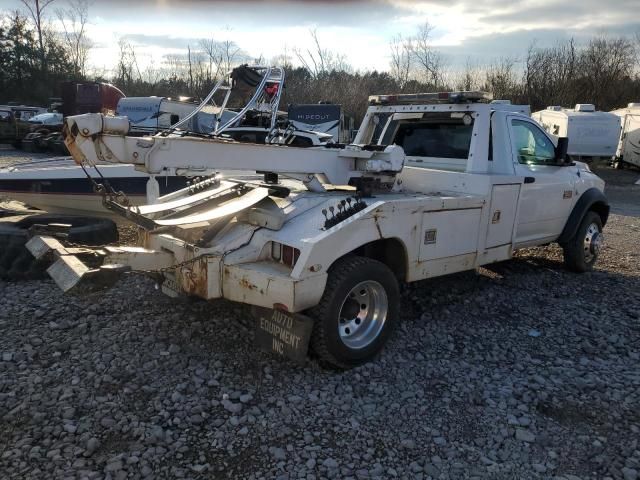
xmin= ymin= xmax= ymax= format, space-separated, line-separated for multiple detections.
xmin=531 ymin=103 xmax=620 ymax=159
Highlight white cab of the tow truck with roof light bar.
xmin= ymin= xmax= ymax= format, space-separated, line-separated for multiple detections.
xmin=356 ymin=92 xmax=608 ymax=248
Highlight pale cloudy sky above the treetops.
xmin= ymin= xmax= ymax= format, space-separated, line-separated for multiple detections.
xmin=0 ymin=0 xmax=640 ymax=75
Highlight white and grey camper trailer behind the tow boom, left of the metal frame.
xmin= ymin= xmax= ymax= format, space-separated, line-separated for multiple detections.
xmin=116 ymin=97 xmax=221 ymax=135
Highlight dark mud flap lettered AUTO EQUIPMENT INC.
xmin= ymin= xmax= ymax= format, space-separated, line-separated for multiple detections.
xmin=251 ymin=306 xmax=313 ymax=363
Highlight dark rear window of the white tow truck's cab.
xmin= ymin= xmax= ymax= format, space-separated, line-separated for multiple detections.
xmin=380 ymin=113 xmax=473 ymax=159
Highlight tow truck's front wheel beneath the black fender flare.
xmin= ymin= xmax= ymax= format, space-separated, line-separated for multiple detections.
xmin=562 ymin=211 xmax=602 ymax=273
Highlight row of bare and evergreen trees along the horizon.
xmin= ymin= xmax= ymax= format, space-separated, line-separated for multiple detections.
xmin=0 ymin=0 xmax=640 ymax=122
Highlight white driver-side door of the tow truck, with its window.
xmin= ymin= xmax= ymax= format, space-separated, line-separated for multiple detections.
xmin=508 ymin=117 xmax=578 ymax=246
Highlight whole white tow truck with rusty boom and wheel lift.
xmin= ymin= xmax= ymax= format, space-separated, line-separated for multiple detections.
xmin=28 ymin=88 xmax=609 ymax=368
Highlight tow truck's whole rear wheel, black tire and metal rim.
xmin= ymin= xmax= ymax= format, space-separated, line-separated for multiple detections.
xmin=309 ymin=256 xmax=400 ymax=369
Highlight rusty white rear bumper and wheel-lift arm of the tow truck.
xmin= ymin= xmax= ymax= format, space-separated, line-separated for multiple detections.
xmin=26 ymin=237 xmax=327 ymax=312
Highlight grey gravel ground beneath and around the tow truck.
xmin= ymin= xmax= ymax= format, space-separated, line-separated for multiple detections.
xmin=0 ymin=151 xmax=640 ymax=480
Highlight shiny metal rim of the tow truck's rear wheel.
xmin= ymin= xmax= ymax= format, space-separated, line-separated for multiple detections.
xmin=338 ymin=280 xmax=389 ymax=350
